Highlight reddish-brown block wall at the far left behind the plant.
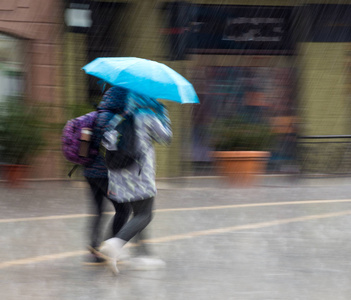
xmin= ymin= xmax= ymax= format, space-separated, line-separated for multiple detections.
xmin=0 ymin=0 xmax=63 ymax=178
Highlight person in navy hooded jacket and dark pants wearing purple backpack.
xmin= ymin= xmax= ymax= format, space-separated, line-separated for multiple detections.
xmin=84 ymin=87 xmax=130 ymax=263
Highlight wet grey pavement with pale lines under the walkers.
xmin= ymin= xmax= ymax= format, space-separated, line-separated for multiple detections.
xmin=0 ymin=177 xmax=351 ymax=300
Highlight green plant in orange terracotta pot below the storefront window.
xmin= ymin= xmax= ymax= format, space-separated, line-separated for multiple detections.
xmin=212 ymin=117 xmax=273 ymax=186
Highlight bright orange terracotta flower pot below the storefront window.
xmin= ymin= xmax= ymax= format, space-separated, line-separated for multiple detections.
xmin=212 ymin=151 xmax=270 ymax=186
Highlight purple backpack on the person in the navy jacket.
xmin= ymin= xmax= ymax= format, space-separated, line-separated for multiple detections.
xmin=61 ymin=111 xmax=98 ymax=166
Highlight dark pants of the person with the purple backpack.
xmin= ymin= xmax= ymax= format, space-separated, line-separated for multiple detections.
xmin=86 ymin=177 xmax=131 ymax=248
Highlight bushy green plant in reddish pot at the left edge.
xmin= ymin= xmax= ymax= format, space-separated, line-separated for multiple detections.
xmin=0 ymin=97 xmax=44 ymax=185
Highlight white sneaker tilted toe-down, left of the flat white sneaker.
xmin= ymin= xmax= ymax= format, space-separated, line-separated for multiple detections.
xmin=99 ymin=238 xmax=125 ymax=275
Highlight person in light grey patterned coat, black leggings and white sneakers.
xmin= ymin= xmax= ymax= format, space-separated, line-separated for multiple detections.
xmin=99 ymin=97 xmax=172 ymax=274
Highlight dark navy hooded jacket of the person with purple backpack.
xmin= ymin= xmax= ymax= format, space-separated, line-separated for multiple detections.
xmin=84 ymin=87 xmax=128 ymax=178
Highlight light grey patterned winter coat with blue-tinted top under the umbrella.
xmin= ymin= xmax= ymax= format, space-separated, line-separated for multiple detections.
xmin=108 ymin=108 xmax=172 ymax=202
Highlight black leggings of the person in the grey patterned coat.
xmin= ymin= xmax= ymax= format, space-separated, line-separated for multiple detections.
xmin=112 ymin=197 xmax=154 ymax=242
